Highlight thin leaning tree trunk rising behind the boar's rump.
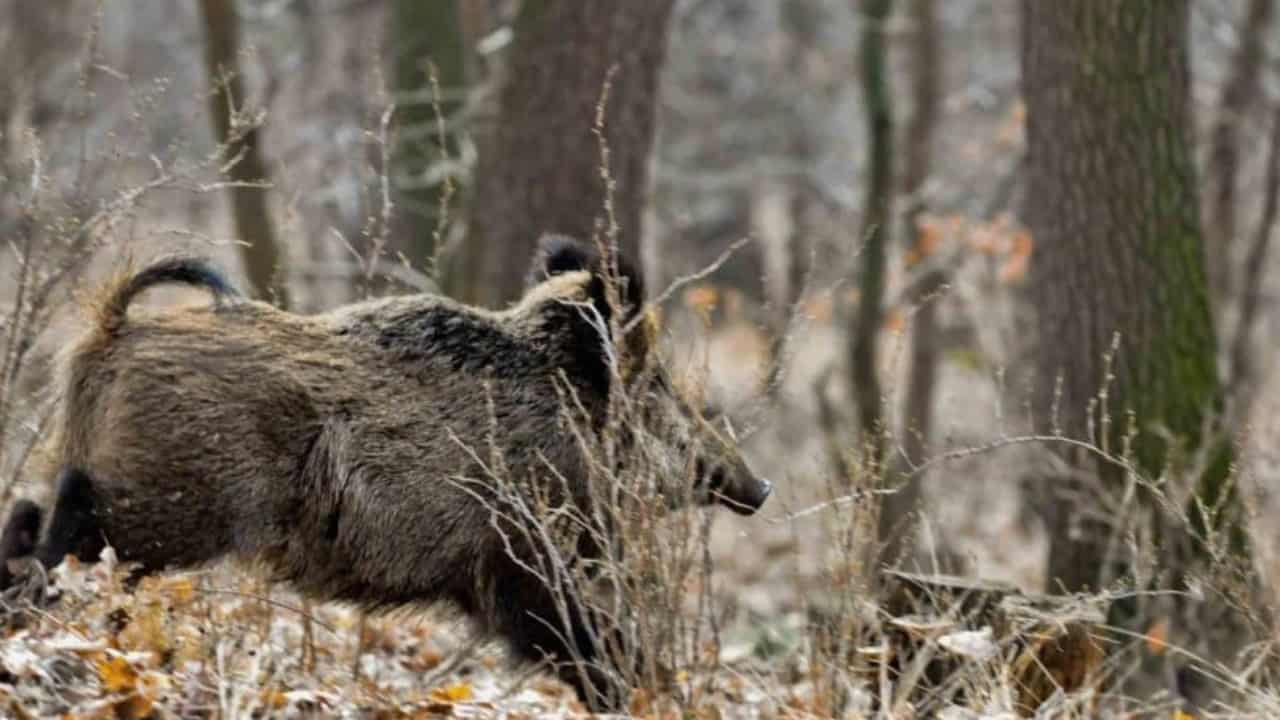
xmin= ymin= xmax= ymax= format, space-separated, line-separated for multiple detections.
xmin=200 ymin=0 xmax=289 ymax=307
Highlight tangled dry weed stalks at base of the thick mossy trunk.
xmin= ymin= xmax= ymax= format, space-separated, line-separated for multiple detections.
xmin=788 ymin=352 xmax=1276 ymax=717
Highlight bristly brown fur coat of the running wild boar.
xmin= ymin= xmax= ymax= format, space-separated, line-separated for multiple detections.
xmin=0 ymin=234 xmax=768 ymax=706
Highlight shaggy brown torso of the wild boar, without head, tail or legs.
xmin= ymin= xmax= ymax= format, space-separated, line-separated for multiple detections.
xmin=64 ymin=274 xmax=603 ymax=610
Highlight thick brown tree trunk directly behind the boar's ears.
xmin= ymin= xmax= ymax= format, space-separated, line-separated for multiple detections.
xmin=458 ymin=0 xmax=673 ymax=305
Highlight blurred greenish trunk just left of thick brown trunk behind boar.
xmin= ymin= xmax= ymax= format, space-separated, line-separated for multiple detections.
xmin=389 ymin=0 xmax=467 ymax=274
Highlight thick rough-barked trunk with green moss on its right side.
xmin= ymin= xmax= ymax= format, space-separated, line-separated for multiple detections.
xmin=1021 ymin=9 xmax=1270 ymax=708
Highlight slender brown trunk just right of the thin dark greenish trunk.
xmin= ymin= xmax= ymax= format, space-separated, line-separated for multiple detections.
xmin=879 ymin=0 xmax=946 ymax=564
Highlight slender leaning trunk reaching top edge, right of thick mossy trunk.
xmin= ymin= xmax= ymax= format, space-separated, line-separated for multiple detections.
xmin=1204 ymin=0 xmax=1275 ymax=302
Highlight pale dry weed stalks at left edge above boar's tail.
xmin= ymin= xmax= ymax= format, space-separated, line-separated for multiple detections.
xmin=0 ymin=43 xmax=279 ymax=506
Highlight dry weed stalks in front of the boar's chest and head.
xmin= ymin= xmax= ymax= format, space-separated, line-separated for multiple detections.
xmin=454 ymin=360 xmax=719 ymax=707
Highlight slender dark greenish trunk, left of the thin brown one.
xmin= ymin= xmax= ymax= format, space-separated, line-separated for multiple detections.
xmin=849 ymin=0 xmax=893 ymax=464
